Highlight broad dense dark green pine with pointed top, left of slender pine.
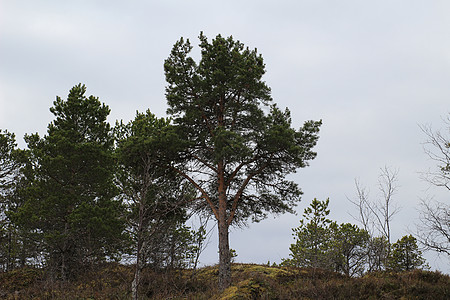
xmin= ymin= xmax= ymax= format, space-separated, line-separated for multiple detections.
xmin=15 ymin=84 xmax=124 ymax=278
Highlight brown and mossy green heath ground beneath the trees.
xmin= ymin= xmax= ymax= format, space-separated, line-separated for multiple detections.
xmin=0 ymin=264 xmax=450 ymax=300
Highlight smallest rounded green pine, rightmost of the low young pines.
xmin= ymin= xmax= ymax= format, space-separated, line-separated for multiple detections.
xmin=389 ymin=235 xmax=425 ymax=271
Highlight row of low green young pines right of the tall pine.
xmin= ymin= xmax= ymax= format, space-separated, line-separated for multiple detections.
xmin=282 ymin=199 xmax=426 ymax=276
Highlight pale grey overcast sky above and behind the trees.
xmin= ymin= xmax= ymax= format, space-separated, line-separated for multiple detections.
xmin=0 ymin=0 xmax=450 ymax=273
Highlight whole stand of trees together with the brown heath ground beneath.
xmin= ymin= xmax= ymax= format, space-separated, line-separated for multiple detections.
xmin=0 ymin=34 xmax=450 ymax=299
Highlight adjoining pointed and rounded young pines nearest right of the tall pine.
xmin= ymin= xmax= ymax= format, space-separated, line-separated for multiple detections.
xmin=282 ymin=199 xmax=385 ymax=276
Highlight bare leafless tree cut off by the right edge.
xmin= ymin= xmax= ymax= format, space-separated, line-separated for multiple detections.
xmin=416 ymin=113 xmax=450 ymax=255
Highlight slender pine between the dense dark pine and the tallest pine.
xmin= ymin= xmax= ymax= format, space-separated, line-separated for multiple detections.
xmin=114 ymin=111 xmax=198 ymax=268
